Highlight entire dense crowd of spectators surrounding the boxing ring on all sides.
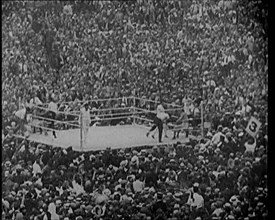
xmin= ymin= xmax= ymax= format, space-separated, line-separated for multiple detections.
xmin=2 ymin=0 xmax=268 ymax=220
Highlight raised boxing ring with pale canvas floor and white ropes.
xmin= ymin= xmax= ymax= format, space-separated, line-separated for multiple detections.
xmin=17 ymin=97 xmax=209 ymax=151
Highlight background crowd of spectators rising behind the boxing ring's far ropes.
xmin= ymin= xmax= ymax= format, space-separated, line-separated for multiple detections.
xmin=2 ymin=1 xmax=268 ymax=117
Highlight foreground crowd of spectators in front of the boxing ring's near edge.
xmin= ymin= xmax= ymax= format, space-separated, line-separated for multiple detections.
xmin=2 ymin=126 xmax=268 ymax=220
